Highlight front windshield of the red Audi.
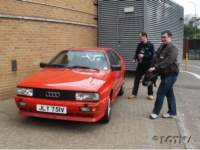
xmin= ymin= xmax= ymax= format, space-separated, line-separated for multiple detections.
xmin=48 ymin=50 xmax=108 ymax=70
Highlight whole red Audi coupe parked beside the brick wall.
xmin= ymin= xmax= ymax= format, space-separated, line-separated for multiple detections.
xmin=15 ymin=48 xmax=125 ymax=123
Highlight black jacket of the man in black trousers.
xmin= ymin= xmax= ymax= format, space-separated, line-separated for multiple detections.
xmin=133 ymin=41 xmax=155 ymax=65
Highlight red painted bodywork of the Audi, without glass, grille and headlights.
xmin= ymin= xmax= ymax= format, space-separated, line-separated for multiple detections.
xmin=15 ymin=48 xmax=125 ymax=122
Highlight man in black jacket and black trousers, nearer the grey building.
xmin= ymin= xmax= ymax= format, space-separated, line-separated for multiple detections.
xmin=128 ymin=32 xmax=155 ymax=100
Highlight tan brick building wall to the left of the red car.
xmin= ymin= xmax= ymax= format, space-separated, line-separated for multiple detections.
xmin=0 ymin=0 xmax=97 ymax=100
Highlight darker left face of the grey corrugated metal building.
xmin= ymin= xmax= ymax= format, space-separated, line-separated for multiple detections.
xmin=98 ymin=0 xmax=144 ymax=70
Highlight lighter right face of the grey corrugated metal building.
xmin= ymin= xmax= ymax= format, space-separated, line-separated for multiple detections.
xmin=144 ymin=0 xmax=183 ymax=62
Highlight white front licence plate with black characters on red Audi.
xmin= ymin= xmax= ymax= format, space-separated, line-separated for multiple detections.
xmin=36 ymin=104 xmax=67 ymax=114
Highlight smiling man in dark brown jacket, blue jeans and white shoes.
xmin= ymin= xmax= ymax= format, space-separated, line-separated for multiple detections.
xmin=149 ymin=30 xmax=179 ymax=119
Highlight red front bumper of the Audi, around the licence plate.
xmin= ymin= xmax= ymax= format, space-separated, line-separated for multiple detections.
xmin=15 ymin=96 xmax=107 ymax=122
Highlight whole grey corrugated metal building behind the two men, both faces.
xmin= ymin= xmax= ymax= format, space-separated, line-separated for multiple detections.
xmin=98 ymin=0 xmax=183 ymax=70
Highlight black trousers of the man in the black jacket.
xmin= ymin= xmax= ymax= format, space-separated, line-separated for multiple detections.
xmin=132 ymin=65 xmax=153 ymax=96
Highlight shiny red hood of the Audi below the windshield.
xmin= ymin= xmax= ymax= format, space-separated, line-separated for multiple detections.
xmin=18 ymin=68 xmax=108 ymax=92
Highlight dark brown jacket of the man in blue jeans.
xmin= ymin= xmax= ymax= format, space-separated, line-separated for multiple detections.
xmin=154 ymin=43 xmax=179 ymax=75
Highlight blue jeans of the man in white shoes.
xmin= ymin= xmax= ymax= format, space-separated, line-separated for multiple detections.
xmin=153 ymin=74 xmax=178 ymax=115
